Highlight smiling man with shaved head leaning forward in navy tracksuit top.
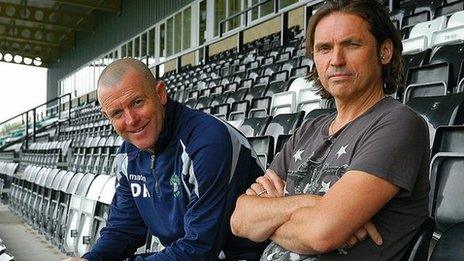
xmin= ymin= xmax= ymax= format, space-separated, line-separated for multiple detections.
xmin=69 ymin=58 xmax=263 ymax=261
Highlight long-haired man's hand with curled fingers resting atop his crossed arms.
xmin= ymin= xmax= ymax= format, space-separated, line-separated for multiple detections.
xmin=246 ymin=169 xmax=285 ymax=198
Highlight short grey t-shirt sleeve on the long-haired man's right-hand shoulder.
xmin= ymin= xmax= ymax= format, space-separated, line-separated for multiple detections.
xmin=348 ymin=108 xmax=430 ymax=196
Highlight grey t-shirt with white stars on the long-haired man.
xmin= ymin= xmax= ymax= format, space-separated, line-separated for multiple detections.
xmin=261 ymin=97 xmax=430 ymax=260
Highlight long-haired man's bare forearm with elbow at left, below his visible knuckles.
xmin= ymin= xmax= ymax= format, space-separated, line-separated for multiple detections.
xmin=231 ymin=195 xmax=320 ymax=242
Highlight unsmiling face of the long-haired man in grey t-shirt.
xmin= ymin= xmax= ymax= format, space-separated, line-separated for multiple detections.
xmin=313 ymin=12 xmax=382 ymax=100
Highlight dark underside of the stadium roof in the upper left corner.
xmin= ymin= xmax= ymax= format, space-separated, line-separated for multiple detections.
xmin=0 ymin=0 xmax=121 ymax=67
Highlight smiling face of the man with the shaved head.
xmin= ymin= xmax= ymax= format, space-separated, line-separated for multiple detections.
xmin=98 ymin=71 xmax=167 ymax=152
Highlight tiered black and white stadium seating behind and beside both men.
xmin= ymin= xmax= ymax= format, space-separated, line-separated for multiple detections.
xmin=0 ymin=0 xmax=464 ymax=260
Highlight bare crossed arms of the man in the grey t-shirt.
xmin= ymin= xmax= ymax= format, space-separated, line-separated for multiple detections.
xmin=231 ymin=170 xmax=399 ymax=254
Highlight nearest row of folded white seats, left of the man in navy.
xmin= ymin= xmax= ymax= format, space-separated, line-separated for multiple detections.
xmin=9 ymin=165 xmax=116 ymax=256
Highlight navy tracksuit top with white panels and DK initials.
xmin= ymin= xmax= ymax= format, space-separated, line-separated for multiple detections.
xmin=83 ymin=99 xmax=263 ymax=261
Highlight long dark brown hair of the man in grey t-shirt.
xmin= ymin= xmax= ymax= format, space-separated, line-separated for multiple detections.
xmin=306 ymin=0 xmax=403 ymax=98
